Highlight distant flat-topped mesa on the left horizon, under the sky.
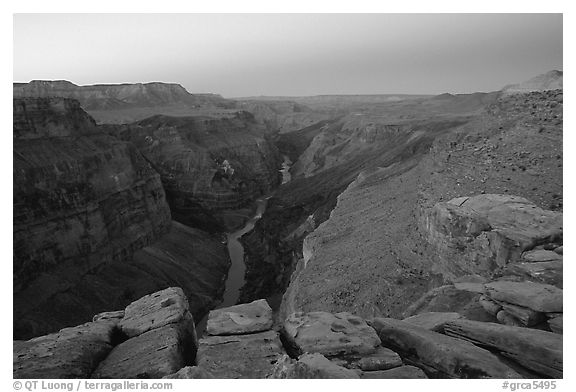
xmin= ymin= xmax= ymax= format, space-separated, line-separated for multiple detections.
xmin=13 ymin=80 xmax=235 ymax=123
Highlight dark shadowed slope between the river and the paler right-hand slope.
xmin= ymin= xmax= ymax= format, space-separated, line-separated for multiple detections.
xmin=242 ymin=118 xmax=468 ymax=309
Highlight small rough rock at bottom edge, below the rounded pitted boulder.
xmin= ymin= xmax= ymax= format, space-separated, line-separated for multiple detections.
xmin=268 ymin=353 xmax=360 ymax=379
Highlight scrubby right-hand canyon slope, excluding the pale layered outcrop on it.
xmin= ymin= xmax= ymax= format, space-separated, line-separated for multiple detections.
xmin=282 ymin=90 xmax=562 ymax=318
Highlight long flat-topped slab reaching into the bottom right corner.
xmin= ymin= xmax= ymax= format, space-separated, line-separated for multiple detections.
xmin=444 ymin=320 xmax=563 ymax=378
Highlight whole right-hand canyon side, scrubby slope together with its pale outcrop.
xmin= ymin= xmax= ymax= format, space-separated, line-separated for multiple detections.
xmin=282 ymin=90 xmax=562 ymax=318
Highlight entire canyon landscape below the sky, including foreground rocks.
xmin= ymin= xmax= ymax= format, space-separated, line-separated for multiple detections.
xmin=14 ymin=71 xmax=563 ymax=378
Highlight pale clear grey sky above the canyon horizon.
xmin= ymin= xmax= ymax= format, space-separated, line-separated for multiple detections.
xmin=13 ymin=13 xmax=563 ymax=98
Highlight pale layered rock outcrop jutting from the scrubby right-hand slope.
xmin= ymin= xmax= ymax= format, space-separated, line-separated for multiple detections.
xmin=423 ymin=194 xmax=562 ymax=276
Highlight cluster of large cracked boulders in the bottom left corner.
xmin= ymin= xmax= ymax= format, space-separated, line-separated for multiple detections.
xmin=13 ymin=288 xmax=198 ymax=378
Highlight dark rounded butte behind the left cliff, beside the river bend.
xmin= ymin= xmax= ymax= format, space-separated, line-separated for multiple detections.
xmin=109 ymin=112 xmax=282 ymax=231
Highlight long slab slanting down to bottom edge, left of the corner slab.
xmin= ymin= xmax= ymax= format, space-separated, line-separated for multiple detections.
xmin=373 ymin=318 xmax=521 ymax=378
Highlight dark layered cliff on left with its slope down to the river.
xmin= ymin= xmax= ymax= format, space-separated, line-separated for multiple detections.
xmin=13 ymin=98 xmax=229 ymax=337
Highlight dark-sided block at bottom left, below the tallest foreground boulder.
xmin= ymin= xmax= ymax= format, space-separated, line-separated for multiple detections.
xmin=92 ymin=313 xmax=196 ymax=378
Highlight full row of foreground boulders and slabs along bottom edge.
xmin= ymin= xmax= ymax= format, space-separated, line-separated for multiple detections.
xmin=13 ymin=288 xmax=548 ymax=379
